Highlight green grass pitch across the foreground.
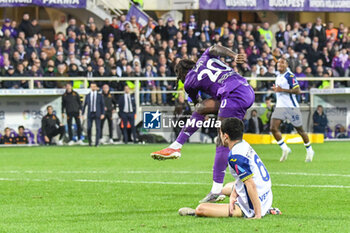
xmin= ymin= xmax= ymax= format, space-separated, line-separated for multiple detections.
xmin=0 ymin=142 xmax=350 ymax=233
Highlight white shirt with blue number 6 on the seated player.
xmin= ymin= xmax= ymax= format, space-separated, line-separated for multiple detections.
xmin=228 ymin=140 xmax=272 ymax=218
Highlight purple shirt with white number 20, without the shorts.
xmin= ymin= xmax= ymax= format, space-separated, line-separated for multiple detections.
xmin=184 ymin=48 xmax=249 ymax=100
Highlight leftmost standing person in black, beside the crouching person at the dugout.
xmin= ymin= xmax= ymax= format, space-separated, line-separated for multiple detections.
xmin=62 ymin=83 xmax=84 ymax=145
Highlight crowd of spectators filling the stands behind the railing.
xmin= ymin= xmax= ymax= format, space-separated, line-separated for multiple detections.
xmin=0 ymin=14 xmax=350 ymax=104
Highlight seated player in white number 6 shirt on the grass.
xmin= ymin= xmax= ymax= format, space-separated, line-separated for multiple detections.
xmin=179 ymin=118 xmax=280 ymax=219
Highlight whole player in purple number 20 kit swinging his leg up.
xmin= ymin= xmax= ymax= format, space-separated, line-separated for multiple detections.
xmin=151 ymin=45 xmax=255 ymax=203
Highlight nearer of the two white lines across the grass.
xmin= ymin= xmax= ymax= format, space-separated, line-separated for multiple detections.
xmin=0 ymin=178 xmax=350 ymax=189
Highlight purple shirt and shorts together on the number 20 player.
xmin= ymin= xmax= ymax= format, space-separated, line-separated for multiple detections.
xmin=184 ymin=48 xmax=255 ymax=120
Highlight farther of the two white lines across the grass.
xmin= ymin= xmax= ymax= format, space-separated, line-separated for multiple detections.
xmin=0 ymin=170 xmax=350 ymax=177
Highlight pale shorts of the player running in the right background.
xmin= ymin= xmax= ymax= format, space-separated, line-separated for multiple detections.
xmin=271 ymin=108 xmax=303 ymax=127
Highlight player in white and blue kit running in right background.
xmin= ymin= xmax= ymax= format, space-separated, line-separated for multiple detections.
xmin=270 ymin=58 xmax=315 ymax=162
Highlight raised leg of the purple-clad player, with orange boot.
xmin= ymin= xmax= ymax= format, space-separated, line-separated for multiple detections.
xmin=151 ymin=99 xmax=220 ymax=160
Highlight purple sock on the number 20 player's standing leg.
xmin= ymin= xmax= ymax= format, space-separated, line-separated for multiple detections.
xmin=213 ymin=146 xmax=230 ymax=184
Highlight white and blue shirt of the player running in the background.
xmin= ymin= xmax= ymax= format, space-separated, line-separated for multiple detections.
xmin=275 ymin=70 xmax=299 ymax=108
